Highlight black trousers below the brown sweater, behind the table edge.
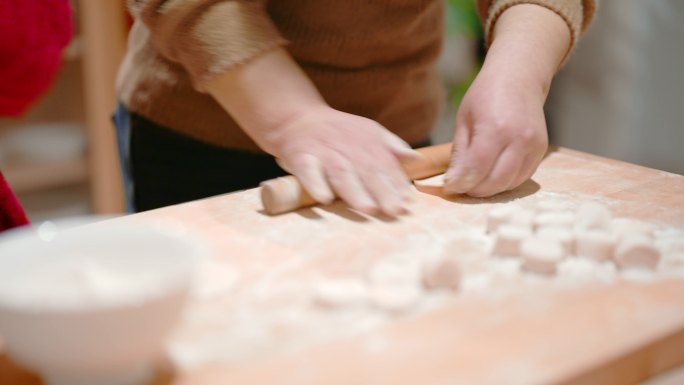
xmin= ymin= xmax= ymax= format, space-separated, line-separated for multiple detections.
xmin=113 ymin=105 xmax=286 ymax=211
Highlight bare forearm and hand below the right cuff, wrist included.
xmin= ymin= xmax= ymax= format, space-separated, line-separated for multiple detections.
xmin=444 ymin=4 xmax=571 ymax=197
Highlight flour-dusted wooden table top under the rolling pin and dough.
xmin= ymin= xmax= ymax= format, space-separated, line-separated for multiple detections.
xmin=0 ymin=148 xmax=684 ymax=385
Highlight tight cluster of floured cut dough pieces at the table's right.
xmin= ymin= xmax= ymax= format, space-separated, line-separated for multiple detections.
xmin=487 ymin=201 xmax=661 ymax=274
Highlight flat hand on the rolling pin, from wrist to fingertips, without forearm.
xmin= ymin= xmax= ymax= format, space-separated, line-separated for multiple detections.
xmin=267 ymin=106 xmax=417 ymax=215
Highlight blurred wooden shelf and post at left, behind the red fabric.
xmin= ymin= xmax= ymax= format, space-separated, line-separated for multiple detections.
xmin=0 ymin=0 xmax=127 ymax=222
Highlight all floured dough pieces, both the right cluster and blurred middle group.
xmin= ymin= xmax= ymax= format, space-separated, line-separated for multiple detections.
xmin=311 ymin=200 xmax=662 ymax=314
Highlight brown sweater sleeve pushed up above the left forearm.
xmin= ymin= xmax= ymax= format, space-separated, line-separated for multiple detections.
xmin=128 ymin=0 xmax=286 ymax=91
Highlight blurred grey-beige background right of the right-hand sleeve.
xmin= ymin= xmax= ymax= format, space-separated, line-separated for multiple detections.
xmin=547 ymin=0 xmax=684 ymax=174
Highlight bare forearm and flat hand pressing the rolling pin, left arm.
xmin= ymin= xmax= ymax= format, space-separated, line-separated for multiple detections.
xmin=207 ymin=49 xmax=417 ymax=215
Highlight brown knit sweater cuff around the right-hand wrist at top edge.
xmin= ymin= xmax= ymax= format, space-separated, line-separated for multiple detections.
xmin=477 ymin=0 xmax=597 ymax=65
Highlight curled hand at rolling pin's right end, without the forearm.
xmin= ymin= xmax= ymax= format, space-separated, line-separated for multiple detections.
xmin=444 ymin=67 xmax=548 ymax=197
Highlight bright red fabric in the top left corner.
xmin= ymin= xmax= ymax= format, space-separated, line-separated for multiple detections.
xmin=0 ymin=0 xmax=73 ymax=116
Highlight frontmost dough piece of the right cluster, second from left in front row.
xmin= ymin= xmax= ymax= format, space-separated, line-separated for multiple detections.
xmin=520 ymin=237 xmax=565 ymax=274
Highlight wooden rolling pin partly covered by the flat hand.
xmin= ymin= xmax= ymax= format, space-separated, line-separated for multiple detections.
xmin=260 ymin=143 xmax=451 ymax=215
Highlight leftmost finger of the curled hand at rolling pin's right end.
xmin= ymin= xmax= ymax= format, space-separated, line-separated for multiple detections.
xmin=444 ymin=127 xmax=504 ymax=194
